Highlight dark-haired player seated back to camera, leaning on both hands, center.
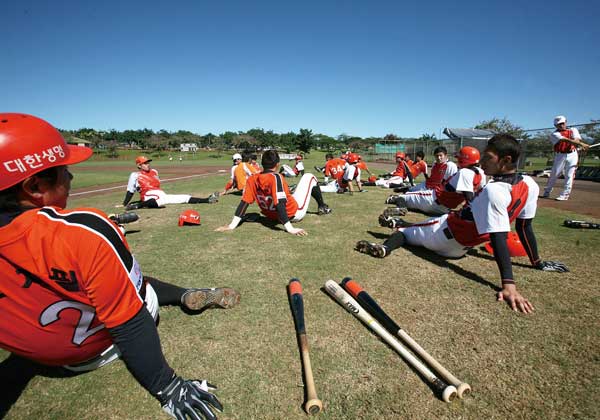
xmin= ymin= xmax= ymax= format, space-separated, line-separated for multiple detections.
xmin=215 ymin=150 xmax=331 ymax=236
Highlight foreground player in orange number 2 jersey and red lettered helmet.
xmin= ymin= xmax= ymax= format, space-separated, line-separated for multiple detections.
xmin=0 ymin=114 xmax=239 ymax=419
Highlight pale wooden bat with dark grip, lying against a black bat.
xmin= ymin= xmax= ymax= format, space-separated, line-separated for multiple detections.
xmin=325 ymin=280 xmax=456 ymax=402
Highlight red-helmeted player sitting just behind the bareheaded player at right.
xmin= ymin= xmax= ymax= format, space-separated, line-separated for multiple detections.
xmin=380 ymin=146 xmax=485 ymax=220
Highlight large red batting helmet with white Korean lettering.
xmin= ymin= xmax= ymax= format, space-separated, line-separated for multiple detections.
xmin=0 ymin=113 xmax=93 ymax=191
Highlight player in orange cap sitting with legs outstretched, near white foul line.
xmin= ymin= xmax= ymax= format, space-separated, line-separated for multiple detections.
xmin=118 ymin=156 xmax=219 ymax=210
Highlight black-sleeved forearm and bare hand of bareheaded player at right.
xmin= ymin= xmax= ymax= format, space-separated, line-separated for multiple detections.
xmin=490 ymin=232 xmax=534 ymax=314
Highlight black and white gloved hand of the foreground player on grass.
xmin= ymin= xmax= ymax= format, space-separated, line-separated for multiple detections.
xmin=156 ymin=375 xmax=223 ymax=420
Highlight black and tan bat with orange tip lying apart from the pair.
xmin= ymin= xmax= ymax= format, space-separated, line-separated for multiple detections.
xmin=288 ymin=278 xmax=323 ymax=414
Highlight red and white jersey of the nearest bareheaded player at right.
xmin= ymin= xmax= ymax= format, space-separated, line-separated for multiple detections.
xmin=448 ymin=174 xmax=540 ymax=246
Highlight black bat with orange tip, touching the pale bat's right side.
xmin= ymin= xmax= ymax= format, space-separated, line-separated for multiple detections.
xmin=342 ymin=277 xmax=471 ymax=398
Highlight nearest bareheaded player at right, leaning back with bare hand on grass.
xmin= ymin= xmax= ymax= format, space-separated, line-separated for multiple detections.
xmin=356 ymin=134 xmax=568 ymax=313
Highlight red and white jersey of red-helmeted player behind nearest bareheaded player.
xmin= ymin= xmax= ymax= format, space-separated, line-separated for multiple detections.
xmin=434 ymin=166 xmax=485 ymax=209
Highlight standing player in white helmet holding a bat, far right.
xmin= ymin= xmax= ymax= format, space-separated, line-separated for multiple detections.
xmin=542 ymin=115 xmax=590 ymax=201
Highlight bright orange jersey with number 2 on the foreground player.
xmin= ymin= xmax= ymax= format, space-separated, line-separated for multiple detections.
xmin=0 ymin=207 xmax=144 ymax=365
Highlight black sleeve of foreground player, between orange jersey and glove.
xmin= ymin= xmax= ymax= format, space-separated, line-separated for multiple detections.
xmin=108 ymin=307 xmax=173 ymax=396
